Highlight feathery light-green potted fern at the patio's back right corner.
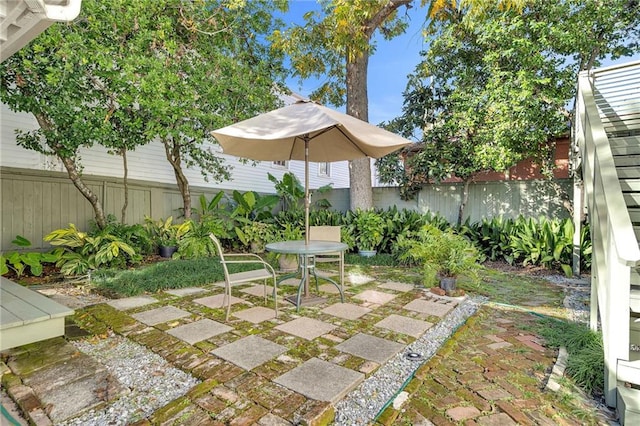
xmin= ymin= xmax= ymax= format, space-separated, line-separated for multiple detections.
xmin=398 ymin=224 xmax=480 ymax=294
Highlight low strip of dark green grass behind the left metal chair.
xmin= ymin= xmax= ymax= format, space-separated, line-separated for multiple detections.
xmin=91 ymin=258 xmax=256 ymax=297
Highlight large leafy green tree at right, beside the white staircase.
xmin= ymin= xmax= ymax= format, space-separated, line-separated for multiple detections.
xmin=379 ymin=0 xmax=640 ymax=225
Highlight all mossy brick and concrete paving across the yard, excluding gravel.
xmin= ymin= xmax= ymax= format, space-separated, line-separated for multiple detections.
xmin=0 ymin=268 xmax=608 ymax=426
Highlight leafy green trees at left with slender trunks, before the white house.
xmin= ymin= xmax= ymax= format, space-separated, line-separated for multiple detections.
xmin=0 ymin=0 xmax=284 ymax=226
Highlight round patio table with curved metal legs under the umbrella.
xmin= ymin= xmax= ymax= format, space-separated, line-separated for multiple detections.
xmin=265 ymin=240 xmax=348 ymax=310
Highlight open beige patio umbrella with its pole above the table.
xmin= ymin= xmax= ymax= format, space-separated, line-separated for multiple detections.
xmin=211 ymin=101 xmax=411 ymax=243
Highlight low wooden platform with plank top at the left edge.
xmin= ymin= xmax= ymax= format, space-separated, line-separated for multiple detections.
xmin=0 ymin=277 xmax=73 ymax=351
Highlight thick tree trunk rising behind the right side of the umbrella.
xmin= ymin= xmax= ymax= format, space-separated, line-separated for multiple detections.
xmin=347 ymin=53 xmax=373 ymax=211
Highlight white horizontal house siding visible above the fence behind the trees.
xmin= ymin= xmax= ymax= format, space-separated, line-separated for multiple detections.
xmin=0 ymin=104 xmax=349 ymax=192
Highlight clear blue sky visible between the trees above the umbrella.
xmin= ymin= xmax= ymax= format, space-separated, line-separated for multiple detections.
xmin=285 ymin=0 xmax=426 ymax=124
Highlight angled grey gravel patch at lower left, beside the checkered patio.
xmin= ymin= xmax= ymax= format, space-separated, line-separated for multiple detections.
xmin=60 ymin=335 xmax=199 ymax=426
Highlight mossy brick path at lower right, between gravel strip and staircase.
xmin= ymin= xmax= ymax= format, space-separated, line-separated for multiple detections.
xmin=377 ymin=305 xmax=610 ymax=426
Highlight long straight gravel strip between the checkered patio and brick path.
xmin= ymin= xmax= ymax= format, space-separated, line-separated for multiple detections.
xmin=335 ymin=297 xmax=487 ymax=426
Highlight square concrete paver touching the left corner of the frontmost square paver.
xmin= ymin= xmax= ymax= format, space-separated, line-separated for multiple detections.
xmin=211 ymin=335 xmax=287 ymax=370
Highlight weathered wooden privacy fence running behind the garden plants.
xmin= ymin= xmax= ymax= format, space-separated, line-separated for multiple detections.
xmin=0 ymin=167 xmax=572 ymax=251
